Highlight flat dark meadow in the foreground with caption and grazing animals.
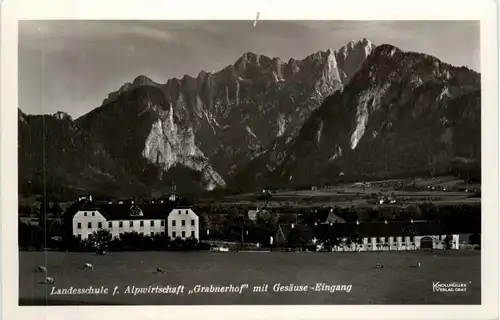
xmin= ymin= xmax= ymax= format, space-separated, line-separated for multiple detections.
xmin=19 ymin=252 xmax=481 ymax=305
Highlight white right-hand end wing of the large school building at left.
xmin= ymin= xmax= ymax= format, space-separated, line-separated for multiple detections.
xmin=167 ymin=208 xmax=200 ymax=239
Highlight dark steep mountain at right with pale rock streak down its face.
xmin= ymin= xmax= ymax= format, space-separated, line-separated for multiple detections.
xmin=267 ymin=45 xmax=481 ymax=185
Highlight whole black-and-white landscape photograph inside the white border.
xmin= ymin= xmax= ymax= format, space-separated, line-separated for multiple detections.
xmin=2 ymin=0 xmax=498 ymax=318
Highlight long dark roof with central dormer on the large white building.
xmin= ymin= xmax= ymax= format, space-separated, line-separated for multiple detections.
xmin=75 ymin=201 xmax=199 ymax=220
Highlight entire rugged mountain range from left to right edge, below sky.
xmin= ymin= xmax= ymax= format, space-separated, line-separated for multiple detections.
xmin=18 ymin=38 xmax=481 ymax=196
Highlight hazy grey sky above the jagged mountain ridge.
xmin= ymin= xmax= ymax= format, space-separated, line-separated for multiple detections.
xmin=18 ymin=20 xmax=480 ymax=118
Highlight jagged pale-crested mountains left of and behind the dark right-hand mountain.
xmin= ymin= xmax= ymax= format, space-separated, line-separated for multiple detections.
xmin=19 ymin=39 xmax=375 ymax=194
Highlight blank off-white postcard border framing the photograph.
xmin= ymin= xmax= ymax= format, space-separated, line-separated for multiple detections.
xmin=0 ymin=0 xmax=499 ymax=320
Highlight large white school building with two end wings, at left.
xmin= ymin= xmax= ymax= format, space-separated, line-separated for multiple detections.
xmin=64 ymin=197 xmax=199 ymax=240
